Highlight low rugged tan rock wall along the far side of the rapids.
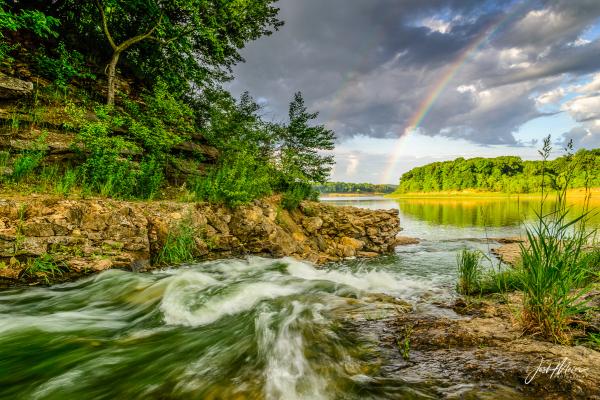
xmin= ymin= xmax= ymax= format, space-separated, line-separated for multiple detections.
xmin=0 ymin=197 xmax=400 ymax=286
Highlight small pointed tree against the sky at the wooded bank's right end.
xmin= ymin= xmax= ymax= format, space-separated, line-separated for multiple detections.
xmin=279 ymin=92 xmax=335 ymax=183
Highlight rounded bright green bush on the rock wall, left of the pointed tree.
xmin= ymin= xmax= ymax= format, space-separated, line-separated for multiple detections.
xmin=191 ymin=152 xmax=273 ymax=207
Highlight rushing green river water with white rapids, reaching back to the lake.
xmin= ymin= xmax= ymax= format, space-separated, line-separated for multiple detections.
xmin=0 ymin=198 xmax=596 ymax=400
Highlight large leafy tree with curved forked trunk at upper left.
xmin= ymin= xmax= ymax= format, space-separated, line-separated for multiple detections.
xmin=33 ymin=0 xmax=283 ymax=103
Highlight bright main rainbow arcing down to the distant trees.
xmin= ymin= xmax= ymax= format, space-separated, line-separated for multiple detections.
xmin=382 ymin=5 xmax=514 ymax=183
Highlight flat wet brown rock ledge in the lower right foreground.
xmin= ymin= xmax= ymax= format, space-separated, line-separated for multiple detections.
xmin=370 ymin=300 xmax=600 ymax=399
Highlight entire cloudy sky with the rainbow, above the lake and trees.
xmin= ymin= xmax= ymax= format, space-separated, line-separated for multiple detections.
xmin=230 ymin=0 xmax=600 ymax=183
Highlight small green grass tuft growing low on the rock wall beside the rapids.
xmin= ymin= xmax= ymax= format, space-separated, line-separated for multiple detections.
xmin=154 ymin=219 xmax=197 ymax=265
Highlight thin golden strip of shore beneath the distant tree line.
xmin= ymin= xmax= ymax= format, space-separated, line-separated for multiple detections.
xmin=384 ymin=188 xmax=600 ymax=200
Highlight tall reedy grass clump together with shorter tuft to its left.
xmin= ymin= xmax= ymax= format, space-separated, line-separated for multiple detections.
xmin=457 ymin=137 xmax=600 ymax=344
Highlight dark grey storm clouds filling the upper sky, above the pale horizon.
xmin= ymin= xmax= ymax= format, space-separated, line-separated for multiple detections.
xmin=231 ymin=0 xmax=600 ymax=145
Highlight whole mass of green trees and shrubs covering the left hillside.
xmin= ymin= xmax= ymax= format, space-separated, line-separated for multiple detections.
xmin=0 ymin=4 xmax=334 ymax=208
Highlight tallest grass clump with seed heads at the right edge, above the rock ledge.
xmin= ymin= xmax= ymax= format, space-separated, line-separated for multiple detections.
xmin=521 ymin=137 xmax=596 ymax=343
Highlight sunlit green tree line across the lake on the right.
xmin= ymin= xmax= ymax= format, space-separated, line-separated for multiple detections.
xmin=396 ymin=149 xmax=600 ymax=193
